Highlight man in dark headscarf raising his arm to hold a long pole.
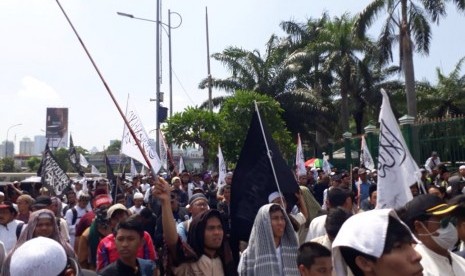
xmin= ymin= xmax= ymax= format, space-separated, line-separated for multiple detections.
xmin=154 ymin=178 xmax=237 ymax=276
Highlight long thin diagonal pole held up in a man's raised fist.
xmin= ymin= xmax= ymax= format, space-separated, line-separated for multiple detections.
xmin=56 ymin=0 xmax=158 ymax=179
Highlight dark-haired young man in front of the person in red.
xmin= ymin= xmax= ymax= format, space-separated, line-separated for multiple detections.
xmin=99 ymin=215 xmax=157 ymax=276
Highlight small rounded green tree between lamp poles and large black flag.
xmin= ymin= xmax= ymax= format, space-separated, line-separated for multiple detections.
xmin=163 ymin=107 xmax=224 ymax=169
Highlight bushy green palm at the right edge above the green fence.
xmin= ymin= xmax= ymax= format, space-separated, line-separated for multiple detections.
xmin=417 ymin=57 xmax=465 ymax=118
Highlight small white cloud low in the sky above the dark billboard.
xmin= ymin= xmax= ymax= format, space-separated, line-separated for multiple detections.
xmin=18 ymin=76 xmax=60 ymax=102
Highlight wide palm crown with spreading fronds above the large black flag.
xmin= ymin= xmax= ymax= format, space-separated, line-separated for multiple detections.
xmin=199 ymin=35 xmax=334 ymax=143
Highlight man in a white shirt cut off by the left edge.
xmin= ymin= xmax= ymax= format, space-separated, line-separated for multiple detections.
xmin=0 ymin=201 xmax=24 ymax=253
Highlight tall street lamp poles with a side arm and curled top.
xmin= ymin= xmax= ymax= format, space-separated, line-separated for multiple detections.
xmin=116 ymin=5 xmax=182 ymax=154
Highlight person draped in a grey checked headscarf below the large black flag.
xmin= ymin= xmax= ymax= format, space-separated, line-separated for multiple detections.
xmin=237 ymin=204 xmax=299 ymax=276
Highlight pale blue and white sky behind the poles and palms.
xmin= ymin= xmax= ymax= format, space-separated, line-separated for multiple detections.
xmin=0 ymin=0 xmax=465 ymax=150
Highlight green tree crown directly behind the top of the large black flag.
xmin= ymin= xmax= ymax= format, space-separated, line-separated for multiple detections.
xmin=220 ymin=91 xmax=295 ymax=164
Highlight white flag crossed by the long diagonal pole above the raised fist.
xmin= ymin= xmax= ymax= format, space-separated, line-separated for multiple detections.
xmin=121 ymin=104 xmax=161 ymax=173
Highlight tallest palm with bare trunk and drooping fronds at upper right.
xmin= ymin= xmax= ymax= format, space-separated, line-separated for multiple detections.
xmin=356 ymin=0 xmax=465 ymax=117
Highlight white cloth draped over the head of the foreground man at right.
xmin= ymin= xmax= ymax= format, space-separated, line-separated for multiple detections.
xmin=332 ymin=209 xmax=416 ymax=276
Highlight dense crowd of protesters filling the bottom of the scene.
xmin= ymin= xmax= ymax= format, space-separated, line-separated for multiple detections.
xmin=0 ymin=153 xmax=465 ymax=276
